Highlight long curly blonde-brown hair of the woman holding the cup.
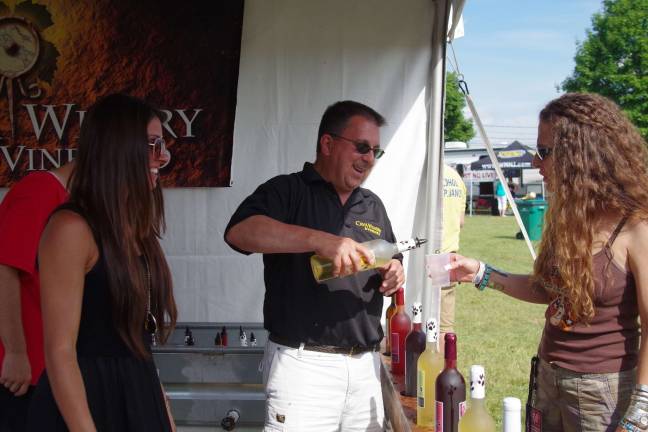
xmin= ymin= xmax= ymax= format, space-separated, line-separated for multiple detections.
xmin=533 ymin=93 xmax=648 ymax=323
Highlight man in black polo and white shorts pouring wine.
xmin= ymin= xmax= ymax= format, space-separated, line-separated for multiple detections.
xmin=225 ymin=101 xmax=405 ymax=432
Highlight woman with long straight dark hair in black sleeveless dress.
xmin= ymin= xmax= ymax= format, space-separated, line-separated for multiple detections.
xmin=28 ymin=94 xmax=177 ymax=431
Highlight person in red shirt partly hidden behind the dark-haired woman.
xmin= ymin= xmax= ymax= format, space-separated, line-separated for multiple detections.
xmin=0 ymin=162 xmax=74 ymax=432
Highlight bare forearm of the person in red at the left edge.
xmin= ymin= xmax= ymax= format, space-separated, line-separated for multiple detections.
xmin=0 ymin=264 xmax=27 ymax=353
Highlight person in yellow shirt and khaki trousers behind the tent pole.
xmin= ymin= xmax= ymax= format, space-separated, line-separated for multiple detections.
xmin=439 ymin=165 xmax=466 ymax=345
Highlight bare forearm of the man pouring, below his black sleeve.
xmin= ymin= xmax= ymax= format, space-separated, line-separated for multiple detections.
xmin=226 ymin=215 xmax=331 ymax=253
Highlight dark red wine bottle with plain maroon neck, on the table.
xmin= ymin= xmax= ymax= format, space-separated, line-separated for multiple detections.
xmin=434 ymin=333 xmax=466 ymax=432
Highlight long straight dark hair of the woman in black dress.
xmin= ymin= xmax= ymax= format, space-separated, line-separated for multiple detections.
xmin=70 ymin=94 xmax=177 ymax=357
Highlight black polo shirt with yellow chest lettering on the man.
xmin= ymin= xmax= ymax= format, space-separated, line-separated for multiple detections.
xmin=225 ymin=162 xmax=396 ymax=347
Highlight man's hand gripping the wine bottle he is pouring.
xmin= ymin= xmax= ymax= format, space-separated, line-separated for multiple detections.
xmin=315 ymin=233 xmax=375 ymax=277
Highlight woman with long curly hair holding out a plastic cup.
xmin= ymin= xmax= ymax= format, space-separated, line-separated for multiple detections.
xmin=452 ymin=93 xmax=648 ymax=431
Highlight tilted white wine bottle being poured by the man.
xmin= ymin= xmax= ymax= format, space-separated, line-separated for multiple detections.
xmin=311 ymin=238 xmax=427 ymax=282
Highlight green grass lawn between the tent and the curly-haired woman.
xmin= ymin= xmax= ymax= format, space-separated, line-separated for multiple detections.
xmin=455 ymin=215 xmax=545 ymax=430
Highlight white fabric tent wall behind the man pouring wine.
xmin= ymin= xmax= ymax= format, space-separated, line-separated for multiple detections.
xmin=1 ymin=0 xmax=463 ymax=322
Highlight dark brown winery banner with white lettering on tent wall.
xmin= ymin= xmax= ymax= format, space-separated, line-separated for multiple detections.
xmin=0 ymin=0 xmax=243 ymax=187
